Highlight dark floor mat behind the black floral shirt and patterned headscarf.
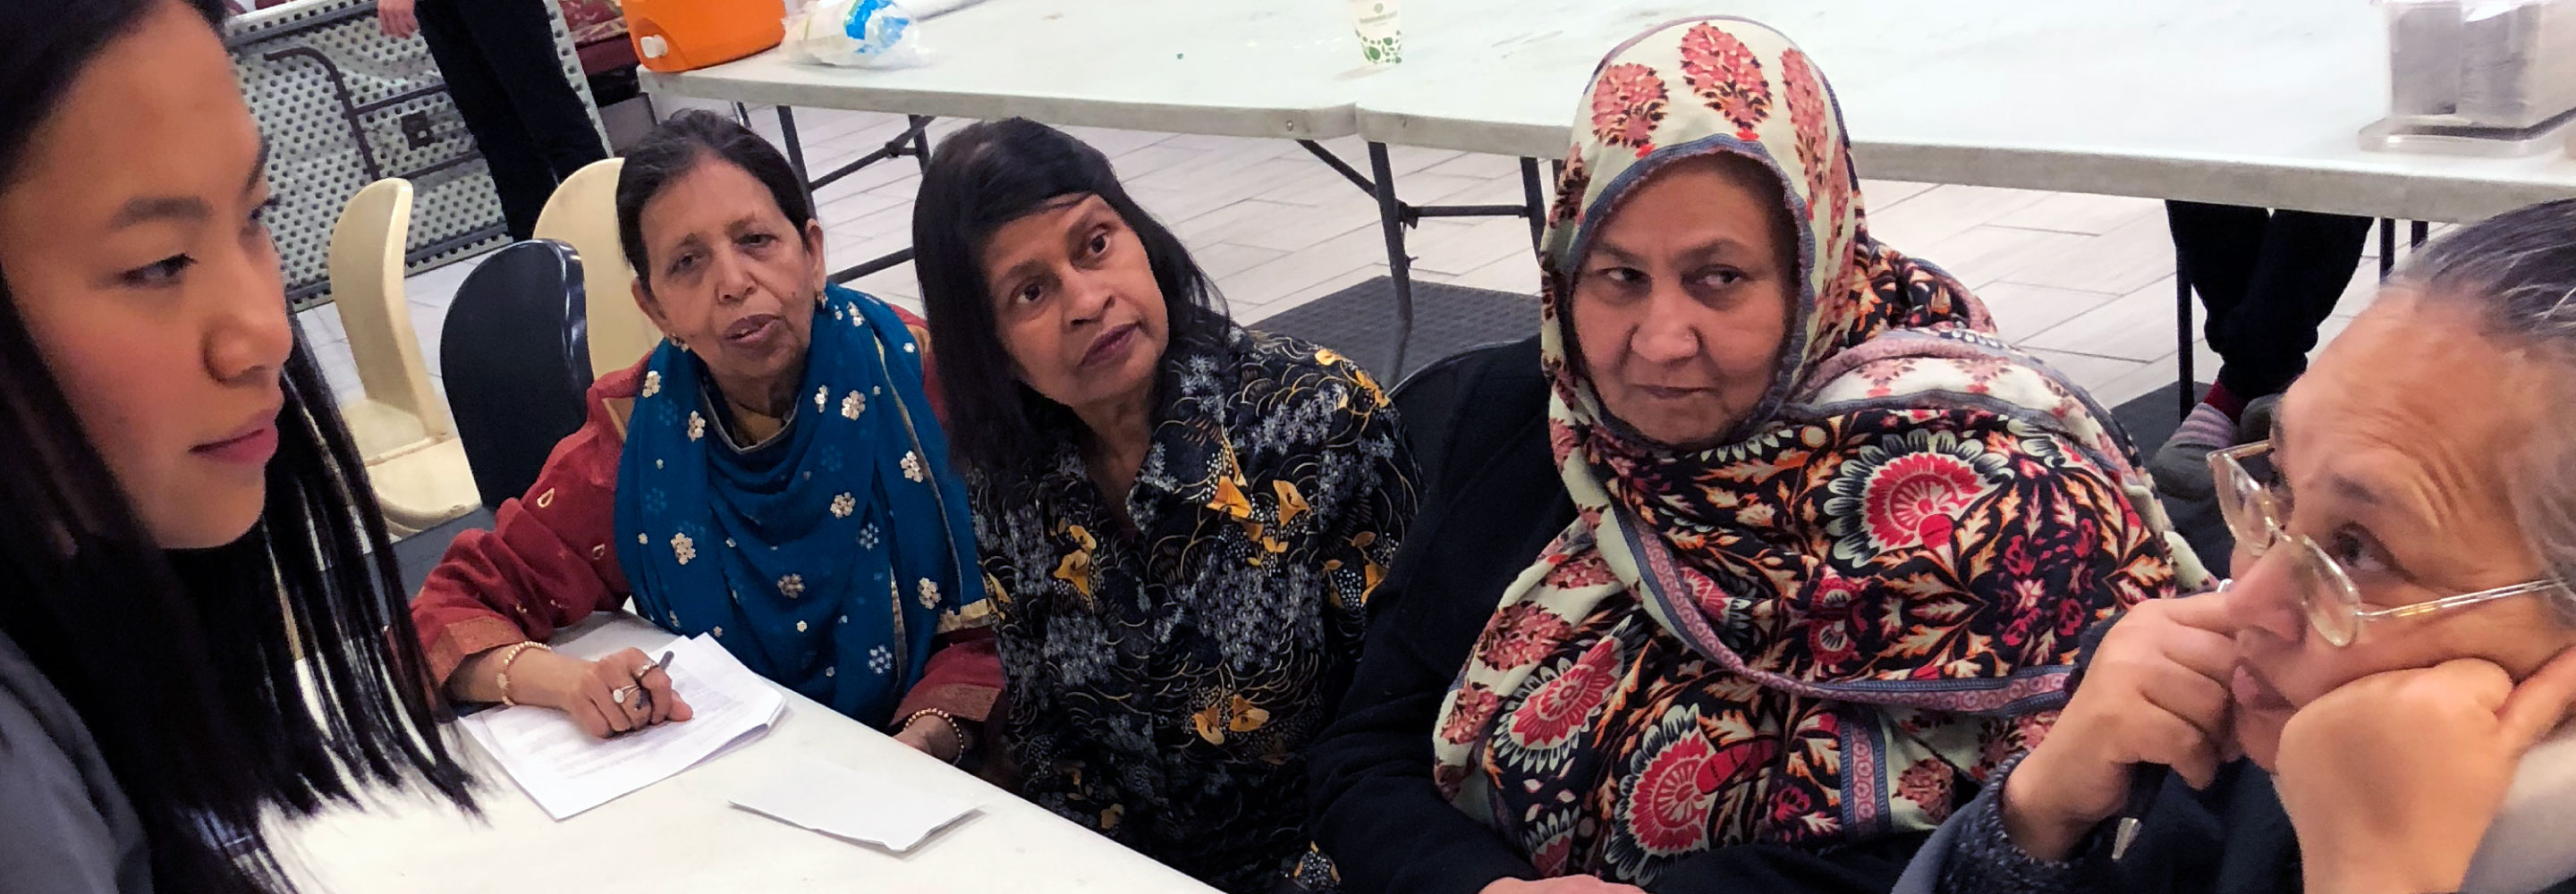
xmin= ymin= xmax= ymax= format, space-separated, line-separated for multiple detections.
xmin=1247 ymin=275 xmax=1538 ymax=386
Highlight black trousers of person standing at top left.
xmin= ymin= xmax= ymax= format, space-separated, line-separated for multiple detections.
xmin=418 ymin=0 xmax=608 ymax=240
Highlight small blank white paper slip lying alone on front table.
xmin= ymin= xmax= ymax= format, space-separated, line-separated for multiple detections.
xmin=734 ymin=757 xmax=979 ymax=853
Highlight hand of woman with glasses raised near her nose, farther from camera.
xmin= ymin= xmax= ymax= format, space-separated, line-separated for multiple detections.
xmin=2002 ymin=593 xmax=2236 ymax=861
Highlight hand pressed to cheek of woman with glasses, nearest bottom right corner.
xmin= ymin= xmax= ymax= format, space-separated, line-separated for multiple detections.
xmin=2272 ymin=652 xmax=2576 ymax=894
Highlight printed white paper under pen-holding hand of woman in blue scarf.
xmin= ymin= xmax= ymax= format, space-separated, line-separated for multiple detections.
xmin=459 ymin=637 xmax=788 ymax=819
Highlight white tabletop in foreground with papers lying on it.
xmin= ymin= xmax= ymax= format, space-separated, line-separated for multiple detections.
xmin=270 ymin=613 xmax=1211 ymax=894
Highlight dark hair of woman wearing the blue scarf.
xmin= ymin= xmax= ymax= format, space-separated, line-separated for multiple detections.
xmin=618 ymin=108 xmax=814 ymax=289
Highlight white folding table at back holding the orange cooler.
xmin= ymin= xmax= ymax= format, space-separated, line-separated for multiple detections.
xmin=644 ymin=0 xmax=1421 ymax=281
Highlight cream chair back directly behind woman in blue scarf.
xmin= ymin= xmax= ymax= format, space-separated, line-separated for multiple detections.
xmin=536 ymin=157 xmax=662 ymax=376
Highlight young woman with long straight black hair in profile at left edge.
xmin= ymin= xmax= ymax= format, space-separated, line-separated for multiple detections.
xmin=0 ymin=0 xmax=471 ymax=894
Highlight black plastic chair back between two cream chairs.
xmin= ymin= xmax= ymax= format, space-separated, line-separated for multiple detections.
xmin=438 ymin=240 xmax=590 ymax=508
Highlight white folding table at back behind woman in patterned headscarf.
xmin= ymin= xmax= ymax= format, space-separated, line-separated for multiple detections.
xmin=1358 ymin=0 xmax=2576 ymax=407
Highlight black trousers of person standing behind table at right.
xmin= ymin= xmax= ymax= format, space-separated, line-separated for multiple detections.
xmin=2164 ymin=201 xmax=2370 ymax=400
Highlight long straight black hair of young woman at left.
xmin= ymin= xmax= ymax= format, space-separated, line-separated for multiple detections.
xmin=0 ymin=0 xmax=471 ymax=894
